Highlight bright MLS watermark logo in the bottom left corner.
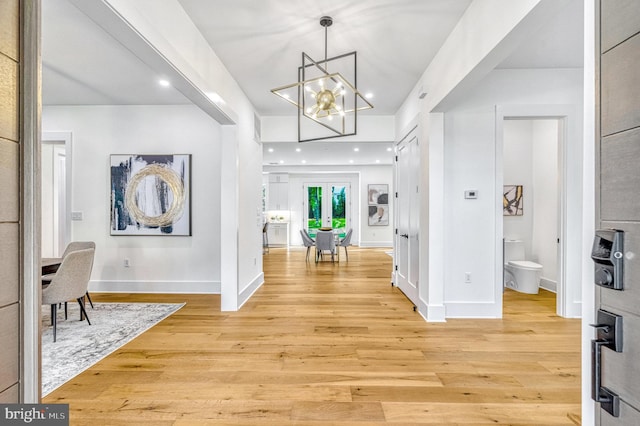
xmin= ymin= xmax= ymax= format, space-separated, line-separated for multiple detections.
xmin=0 ymin=404 xmax=69 ymax=426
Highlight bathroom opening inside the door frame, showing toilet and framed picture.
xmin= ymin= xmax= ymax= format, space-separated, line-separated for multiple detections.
xmin=502 ymin=118 xmax=563 ymax=303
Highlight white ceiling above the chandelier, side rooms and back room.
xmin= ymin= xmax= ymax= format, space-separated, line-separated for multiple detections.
xmin=42 ymin=0 xmax=582 ymax=164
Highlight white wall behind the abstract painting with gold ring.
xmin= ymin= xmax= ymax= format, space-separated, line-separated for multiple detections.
xmin=42 ymin=105 xmax=221 ymax=293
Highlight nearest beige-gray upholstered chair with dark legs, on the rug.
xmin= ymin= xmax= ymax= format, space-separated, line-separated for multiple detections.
xmin=42 ymin=248 xmax=95 ymax=342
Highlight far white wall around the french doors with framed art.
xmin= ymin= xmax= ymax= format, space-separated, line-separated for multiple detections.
xmin=264 ymin=165 xmax=395 ymax=247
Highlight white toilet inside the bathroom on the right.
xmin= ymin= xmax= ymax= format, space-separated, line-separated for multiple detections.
xmin=504 ymin=240 xmax=542 ymax=294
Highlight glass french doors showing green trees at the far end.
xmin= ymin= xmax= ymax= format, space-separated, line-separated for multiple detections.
xmin=304 ymin=183 xmax=351 ymax=233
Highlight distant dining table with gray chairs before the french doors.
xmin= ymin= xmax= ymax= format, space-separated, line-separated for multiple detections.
xmin=300 ymin=227 xmax=353 ymax=264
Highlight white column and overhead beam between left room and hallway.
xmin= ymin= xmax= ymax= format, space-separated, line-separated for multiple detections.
xmin=95 ymin=0 xmax=264 ymax=311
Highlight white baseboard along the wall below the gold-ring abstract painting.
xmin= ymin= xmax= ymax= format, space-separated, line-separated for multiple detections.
xmin=89 ymin=280 xmax=221 ymax=294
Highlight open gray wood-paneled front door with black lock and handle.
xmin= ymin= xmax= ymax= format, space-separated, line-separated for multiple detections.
xmin=592 ymin=0 xmax=640 ymax=425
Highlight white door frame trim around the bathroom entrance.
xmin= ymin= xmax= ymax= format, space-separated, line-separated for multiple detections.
xmin=494 ymin=105 xmax=582 ymax=318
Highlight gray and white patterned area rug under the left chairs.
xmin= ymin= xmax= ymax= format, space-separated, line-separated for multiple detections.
xmin=42 ymin=302 xmax=184 ymax=396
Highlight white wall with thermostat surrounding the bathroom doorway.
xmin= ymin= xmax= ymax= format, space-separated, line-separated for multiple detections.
xmin=444 ymin=69 xmax=582 ymax=317
